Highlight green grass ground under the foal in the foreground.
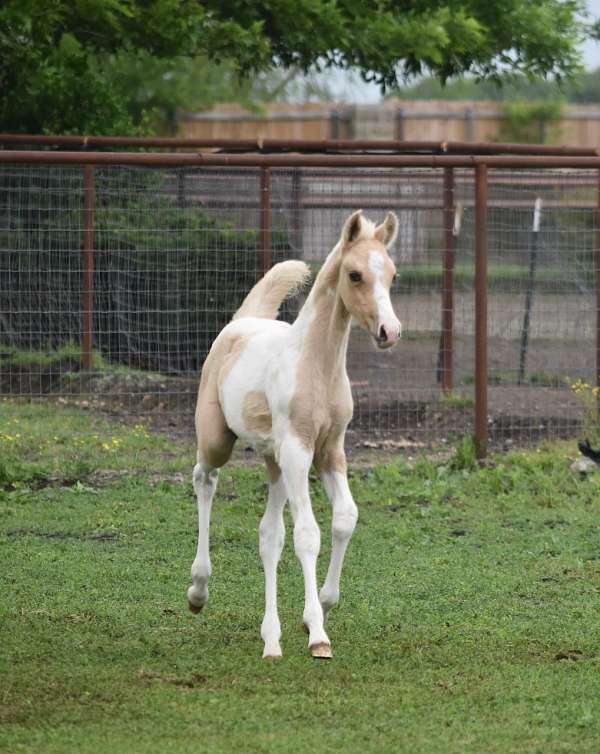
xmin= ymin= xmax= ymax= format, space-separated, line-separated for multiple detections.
xmin=0 ymin=401 xmax=600 ymax=754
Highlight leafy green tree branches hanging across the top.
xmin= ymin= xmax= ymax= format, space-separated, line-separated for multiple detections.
xmin=0 ymin=0 xmax=592 ymax=133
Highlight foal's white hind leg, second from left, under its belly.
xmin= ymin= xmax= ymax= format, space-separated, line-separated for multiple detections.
xmin=259 ymin=457 xmax=287 ymax=657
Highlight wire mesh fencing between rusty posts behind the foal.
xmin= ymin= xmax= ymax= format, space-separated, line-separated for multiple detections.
xmin=0 ymin=156 xmax=598 ymax=449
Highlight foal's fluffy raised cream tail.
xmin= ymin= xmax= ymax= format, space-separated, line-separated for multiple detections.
xmin=232 ymin=259 xmax=310 ymax=319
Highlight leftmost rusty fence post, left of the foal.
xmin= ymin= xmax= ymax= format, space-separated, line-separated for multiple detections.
xmin=81 ymin=165 xmax=96 ymax=369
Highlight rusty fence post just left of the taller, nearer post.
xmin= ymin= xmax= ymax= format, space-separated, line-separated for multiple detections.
xmin=441 ymin=168 xmax=454 ymax=393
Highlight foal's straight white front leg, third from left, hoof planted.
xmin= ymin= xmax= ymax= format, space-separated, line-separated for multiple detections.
xmin=279 ymin=436 xmax=331 ymax=658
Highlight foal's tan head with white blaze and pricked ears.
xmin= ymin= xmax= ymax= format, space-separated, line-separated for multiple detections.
xmin=338 ymin=210 xmax=402 ymax=348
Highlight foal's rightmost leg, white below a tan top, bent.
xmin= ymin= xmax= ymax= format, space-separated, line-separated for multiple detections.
xmin=319 ymin=451 xmax=358 ymax=619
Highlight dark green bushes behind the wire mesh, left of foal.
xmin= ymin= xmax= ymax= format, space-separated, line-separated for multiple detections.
xmin=0 ymin=169 xmax=290 ymax=376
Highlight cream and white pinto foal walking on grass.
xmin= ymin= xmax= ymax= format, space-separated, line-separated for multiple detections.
xmin=187 ymin=211 xmax=401 ymax=658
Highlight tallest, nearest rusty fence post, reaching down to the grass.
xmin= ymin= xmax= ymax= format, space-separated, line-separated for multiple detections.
xmin=475 ymin=164 xmax=488 ymax=459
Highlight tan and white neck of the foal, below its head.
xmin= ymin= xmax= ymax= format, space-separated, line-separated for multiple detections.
xmin=293 ymin=248 xmax=350 ymax=378
